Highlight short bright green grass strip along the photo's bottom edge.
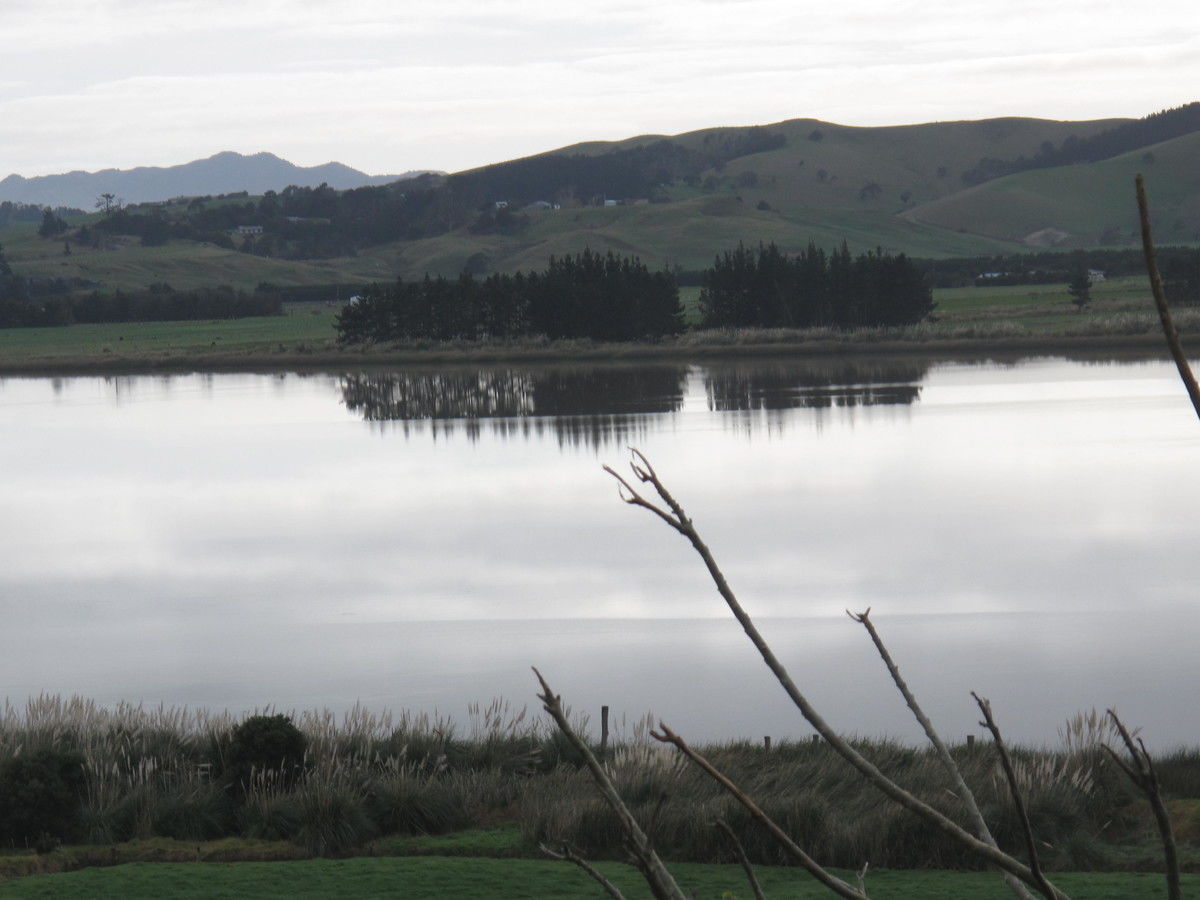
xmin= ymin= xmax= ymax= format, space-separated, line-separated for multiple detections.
xmin=0 ymin=857 xmax=1185 ymax=900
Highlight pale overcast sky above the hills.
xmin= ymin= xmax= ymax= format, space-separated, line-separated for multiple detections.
xmin=0 ymin=0 xmax=1200 ymax=178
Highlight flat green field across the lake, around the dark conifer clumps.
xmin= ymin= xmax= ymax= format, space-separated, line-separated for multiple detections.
xmin=0 ymin=277 xmax=1200 ymax=372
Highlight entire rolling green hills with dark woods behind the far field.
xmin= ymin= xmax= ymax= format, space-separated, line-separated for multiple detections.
xmin=0 ymin=103 xmax=1200 ymax=287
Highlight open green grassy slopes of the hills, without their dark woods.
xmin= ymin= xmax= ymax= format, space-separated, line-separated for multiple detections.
xmin=0 ymin=110 xmax=1200 ymax=289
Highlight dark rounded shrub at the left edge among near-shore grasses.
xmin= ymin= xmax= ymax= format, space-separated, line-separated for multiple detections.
xmin=0 ymin=750 xmax=84 ymax=845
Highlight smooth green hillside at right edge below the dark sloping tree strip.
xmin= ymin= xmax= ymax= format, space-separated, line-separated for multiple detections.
xmin=902 ymin=133 xmax=1200 ymax=247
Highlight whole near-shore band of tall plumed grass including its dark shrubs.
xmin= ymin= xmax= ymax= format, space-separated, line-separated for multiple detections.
xmin=0 ymin=696 xmax=1200 ymax=898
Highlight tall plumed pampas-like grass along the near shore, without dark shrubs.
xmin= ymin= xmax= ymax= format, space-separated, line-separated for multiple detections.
xmin=0 ymin=695 xmax=1200 ymax=869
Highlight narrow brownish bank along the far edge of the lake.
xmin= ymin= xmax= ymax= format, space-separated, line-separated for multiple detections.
xmin=0 ymin=331 xmax=1169 ymax=376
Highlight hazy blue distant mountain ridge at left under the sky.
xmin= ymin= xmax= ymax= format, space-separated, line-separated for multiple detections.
xmin=0 ymin=150 xmax=436 ymax=210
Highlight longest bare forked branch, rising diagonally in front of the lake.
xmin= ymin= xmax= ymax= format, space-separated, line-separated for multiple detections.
xmin=609 ymin=450 xmax=1066 ymax=900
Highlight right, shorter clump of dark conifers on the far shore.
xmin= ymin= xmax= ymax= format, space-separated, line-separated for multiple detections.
xmin=700 ymin=241 xmax=934 ymax=328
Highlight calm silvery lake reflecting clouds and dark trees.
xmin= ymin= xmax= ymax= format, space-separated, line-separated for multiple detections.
xmin=0 ymin=359 xmax=1200 ymax=746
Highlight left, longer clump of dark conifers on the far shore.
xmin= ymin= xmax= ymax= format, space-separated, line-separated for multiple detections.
xmin=336 ymin=250 xmax=683 ymax=343
